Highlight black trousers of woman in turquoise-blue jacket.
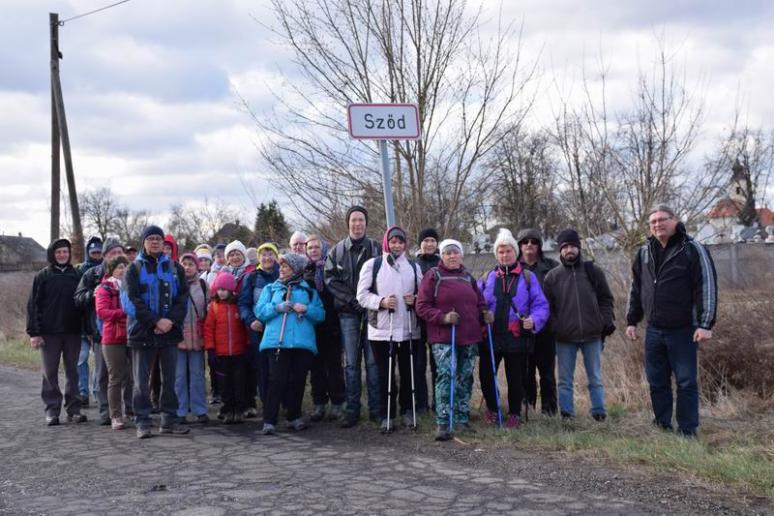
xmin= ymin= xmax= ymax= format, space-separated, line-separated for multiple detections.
xmin=262 ymin=349 xmax=314 ymax=425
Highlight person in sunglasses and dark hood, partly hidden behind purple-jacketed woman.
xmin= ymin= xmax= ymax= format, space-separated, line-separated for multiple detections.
xmin=518 ymin=229 xmax=559 ymax=416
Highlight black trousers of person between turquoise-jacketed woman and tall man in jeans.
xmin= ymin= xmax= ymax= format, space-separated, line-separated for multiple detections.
xmin=311 ymin=331 xmax=344 ymax=405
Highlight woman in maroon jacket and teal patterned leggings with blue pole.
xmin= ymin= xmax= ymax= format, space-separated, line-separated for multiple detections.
xmin=416 ymin=239 xmax=493 ymax=441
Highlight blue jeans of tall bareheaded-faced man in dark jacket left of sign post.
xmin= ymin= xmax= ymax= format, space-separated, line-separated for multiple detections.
xmin=339 ymin=315 xmax=379 ymax=419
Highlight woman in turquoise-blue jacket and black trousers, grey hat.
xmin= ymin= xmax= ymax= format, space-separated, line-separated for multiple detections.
xmin=255 ymin=253 xmax=325 ymax=434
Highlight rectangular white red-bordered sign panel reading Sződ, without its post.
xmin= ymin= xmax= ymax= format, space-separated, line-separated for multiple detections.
xmin=347 ymin=104 xmax=420 ymax=140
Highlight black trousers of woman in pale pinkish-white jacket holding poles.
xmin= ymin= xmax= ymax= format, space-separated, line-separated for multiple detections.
xmin=369 ymin=340 xmax=420 ymax=419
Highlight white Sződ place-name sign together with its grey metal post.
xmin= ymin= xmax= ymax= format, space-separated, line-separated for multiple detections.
xmin=347 ymin=104 xmax=420 ymax=227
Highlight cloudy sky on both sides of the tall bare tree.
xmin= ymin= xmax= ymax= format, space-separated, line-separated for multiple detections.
xmin=0 ymin=0 xmax=774 ymax=243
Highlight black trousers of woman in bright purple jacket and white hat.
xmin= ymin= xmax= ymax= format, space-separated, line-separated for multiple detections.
xmin=478 ymin=342 xmax=527 ymax=416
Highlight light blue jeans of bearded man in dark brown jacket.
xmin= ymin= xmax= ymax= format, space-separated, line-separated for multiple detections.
xmin=556 ymin=339 xmax=606 ymax=416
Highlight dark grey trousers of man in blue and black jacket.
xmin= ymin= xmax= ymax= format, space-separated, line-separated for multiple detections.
xmin=131 ymin=346 xmax=178 ymax=428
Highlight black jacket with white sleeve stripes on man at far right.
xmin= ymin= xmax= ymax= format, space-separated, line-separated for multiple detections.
xmin=626 ymin=224 xmax=718 ymax=330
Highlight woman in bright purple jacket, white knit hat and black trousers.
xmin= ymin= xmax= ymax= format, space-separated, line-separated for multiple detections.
xmin=478 ymin=228 xmax=549 ymax=429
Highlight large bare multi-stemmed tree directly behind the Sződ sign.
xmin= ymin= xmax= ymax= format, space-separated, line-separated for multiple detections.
xmin=244 ymin=0 xmax=534 ymax=241
